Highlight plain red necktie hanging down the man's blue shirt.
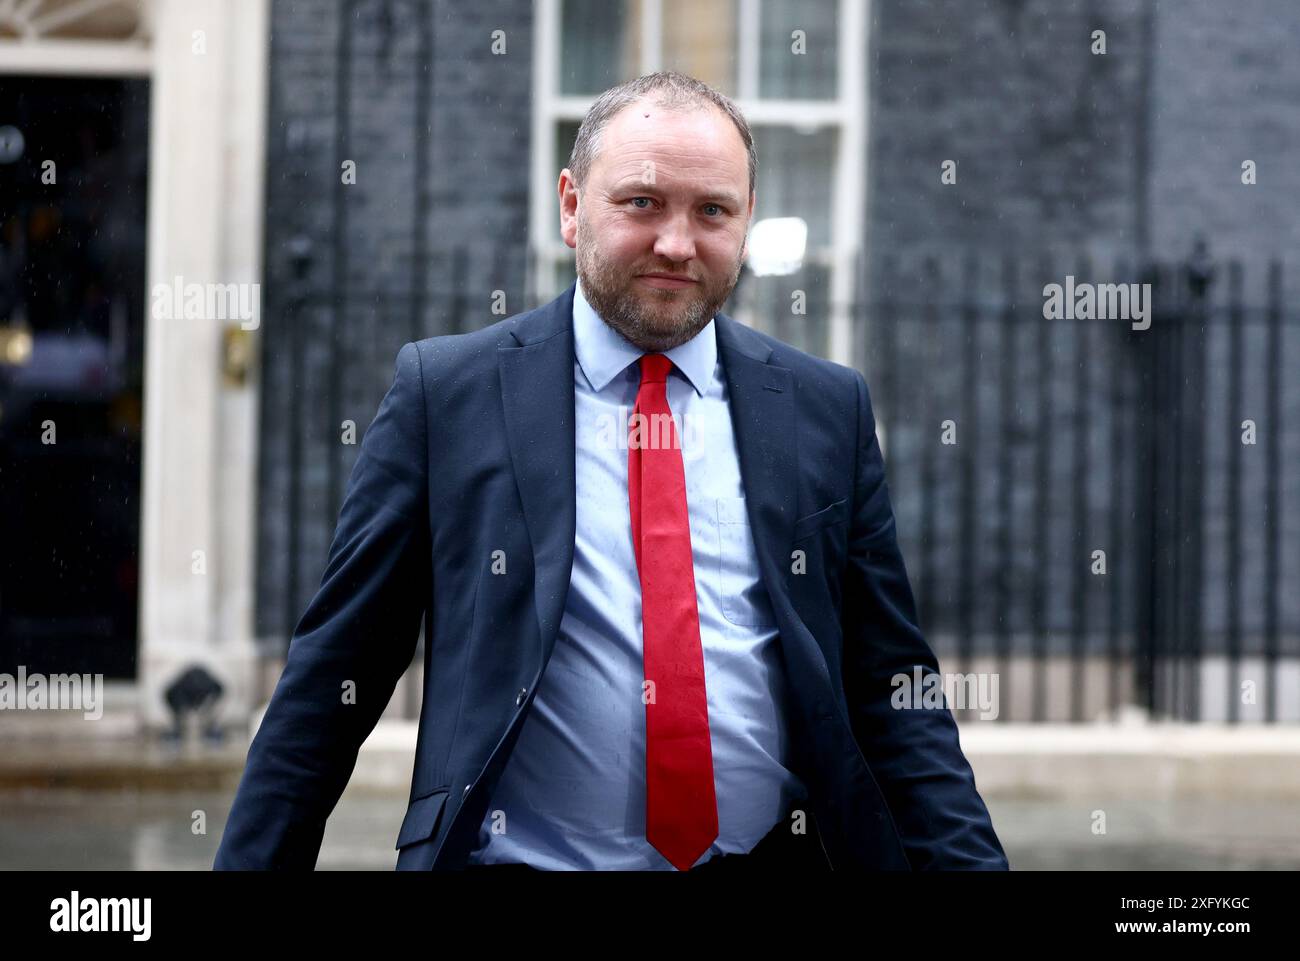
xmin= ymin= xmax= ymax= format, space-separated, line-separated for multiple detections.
xmin=628 ymin=354 xmax=718 ymax=871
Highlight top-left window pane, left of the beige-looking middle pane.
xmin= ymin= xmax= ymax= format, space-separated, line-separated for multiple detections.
xmin=559 ymin=0 xmax=641 ymax=95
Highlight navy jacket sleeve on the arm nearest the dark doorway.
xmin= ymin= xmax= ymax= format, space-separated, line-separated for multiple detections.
xmin=213 ymin=343 xmax=432 ymax=870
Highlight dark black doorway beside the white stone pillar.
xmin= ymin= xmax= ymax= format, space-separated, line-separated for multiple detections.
xmin=0 ymin=75 xmax=150 ymax=679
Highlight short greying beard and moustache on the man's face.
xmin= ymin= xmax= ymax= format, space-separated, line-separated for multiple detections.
xmin=577 ymin=215 xmax=744 ymax=354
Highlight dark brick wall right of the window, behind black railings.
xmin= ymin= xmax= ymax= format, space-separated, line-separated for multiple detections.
xmin=859 ymin=0 xmax=1300 ymax=653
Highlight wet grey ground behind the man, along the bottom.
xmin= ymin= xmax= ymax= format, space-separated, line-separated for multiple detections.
xmin=0 ymin=789 xmax=1300 ymax=871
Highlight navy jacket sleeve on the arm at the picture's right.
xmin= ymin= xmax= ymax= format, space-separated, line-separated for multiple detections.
xmin=842 ymin=371 xmax=1009 ymax=870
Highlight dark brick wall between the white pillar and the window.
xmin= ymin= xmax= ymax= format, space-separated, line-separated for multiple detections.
xmin=257 ymin=0 xmax=533 ymax=646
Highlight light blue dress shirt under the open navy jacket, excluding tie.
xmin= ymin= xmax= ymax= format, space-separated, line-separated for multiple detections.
xmin=469 ymin=283 xmax=807 ymax=870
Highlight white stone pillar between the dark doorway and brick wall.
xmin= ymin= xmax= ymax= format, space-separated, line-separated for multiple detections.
xmin=139 ymin=0 xmax=269 ymax=730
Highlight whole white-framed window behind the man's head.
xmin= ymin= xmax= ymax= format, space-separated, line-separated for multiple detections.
xmin=530 ymin=0 xmax=867 ymax=363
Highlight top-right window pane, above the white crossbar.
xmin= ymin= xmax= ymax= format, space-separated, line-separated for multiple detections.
xmin=758 ymin=0 xmax=837 ymax=100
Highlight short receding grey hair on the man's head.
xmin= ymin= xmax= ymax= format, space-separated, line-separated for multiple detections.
xmin=568 ymin=70 xmax=758 ymax=194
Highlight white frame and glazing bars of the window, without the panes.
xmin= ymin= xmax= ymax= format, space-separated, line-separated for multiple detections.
xmin=529 ymin=0 xmax=870 ymax=364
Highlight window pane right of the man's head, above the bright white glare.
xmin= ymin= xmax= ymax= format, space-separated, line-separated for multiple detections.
xmin=754 ymin=126 xmax=836 ymax=247
